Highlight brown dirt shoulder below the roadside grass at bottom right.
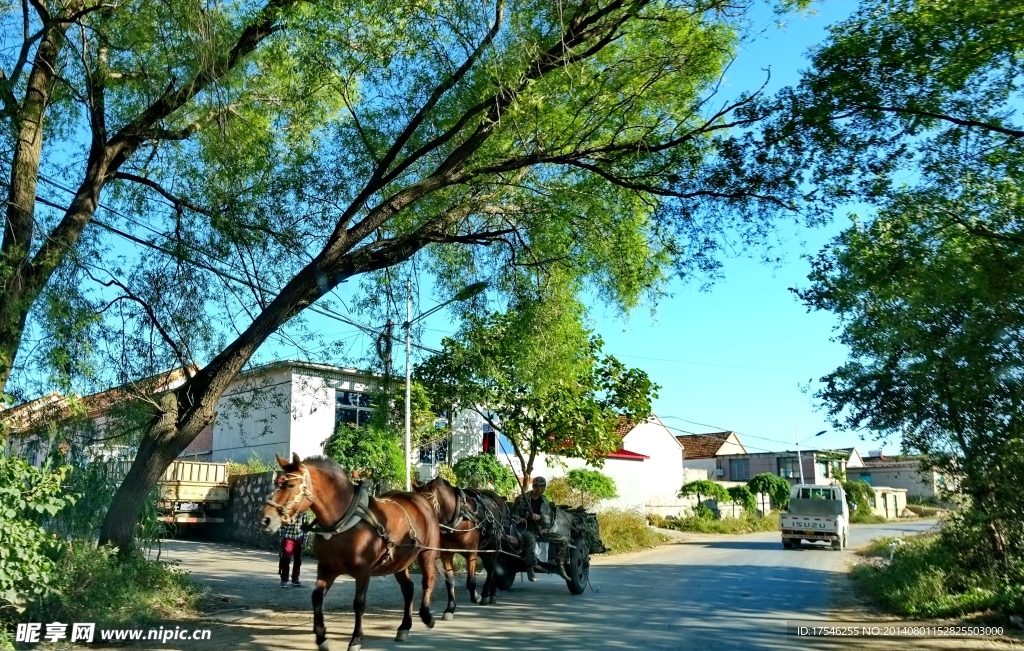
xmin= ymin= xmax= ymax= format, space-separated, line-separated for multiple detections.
xmin=823 ymin=557 xmax=1024 ymax=651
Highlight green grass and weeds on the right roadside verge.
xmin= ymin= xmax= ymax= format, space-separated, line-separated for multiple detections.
xmin=853 ymin=534 xmax=1024 ymax=617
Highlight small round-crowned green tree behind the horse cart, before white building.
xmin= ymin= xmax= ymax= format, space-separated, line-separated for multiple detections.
xmin=417 ymin=286 xmax=656 ymax=490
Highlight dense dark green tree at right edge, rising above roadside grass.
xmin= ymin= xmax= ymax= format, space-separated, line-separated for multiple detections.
xmin=800 ymin=192 xmax=1024 ymax=558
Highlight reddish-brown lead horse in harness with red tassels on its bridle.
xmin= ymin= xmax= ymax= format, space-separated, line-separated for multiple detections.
xmin=262 ymin=454 xmax=440 ymax=651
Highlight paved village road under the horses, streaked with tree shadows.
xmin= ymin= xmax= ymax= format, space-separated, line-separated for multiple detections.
xmin=135 ymin=522 xmax=962 ymax=651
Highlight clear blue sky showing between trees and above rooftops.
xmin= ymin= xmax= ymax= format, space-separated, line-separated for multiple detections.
xmin=274 ymin=1 xmax=895 ymax=451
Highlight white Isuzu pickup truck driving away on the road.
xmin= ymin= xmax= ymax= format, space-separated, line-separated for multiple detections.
xmin=778 ymin=484 xmax=850 ymax=551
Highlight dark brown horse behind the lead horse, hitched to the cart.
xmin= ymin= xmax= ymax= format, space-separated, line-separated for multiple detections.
xmin=416 ymin=477 xmax=508 ymax=619
